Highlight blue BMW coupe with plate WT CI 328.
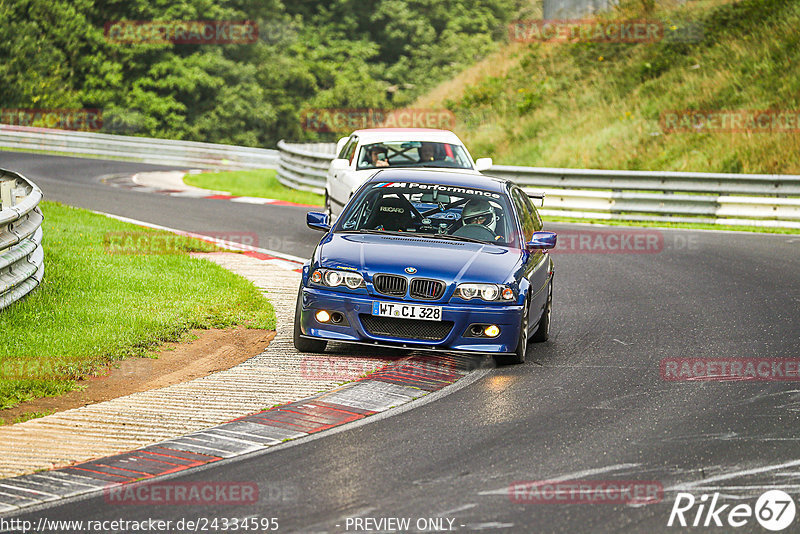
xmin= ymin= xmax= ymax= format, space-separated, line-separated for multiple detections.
xmin=294 ymin=169 xmax=556 ymax=363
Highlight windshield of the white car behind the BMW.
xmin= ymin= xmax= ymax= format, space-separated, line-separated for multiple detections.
xmin=356 ymin=141 xmax=472 ymax=170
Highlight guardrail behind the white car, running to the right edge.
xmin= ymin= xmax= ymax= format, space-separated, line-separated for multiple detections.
xmin=278 ymin=141 xmax=800 ymax=228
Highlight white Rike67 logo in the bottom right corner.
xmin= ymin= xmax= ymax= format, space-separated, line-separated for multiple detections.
xmin=667 ymin=490 xmax=797 ymax=532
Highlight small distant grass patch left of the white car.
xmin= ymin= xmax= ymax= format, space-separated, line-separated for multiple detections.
xmin=183 ymin=169 xmax=324 ymax=206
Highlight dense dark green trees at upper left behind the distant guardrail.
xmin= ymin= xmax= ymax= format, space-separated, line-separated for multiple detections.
xmin=0 ymin=0 xmax=519 ymax=146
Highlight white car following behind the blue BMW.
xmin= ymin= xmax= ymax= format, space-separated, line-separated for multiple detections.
xmin=325 ymin=128 xmax=492 ymax=219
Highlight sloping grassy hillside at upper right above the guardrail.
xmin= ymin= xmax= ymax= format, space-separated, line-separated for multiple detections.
xmin=428 ymin=0 xmax=800 ymax=174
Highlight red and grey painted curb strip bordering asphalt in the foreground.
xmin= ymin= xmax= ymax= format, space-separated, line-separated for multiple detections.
xmin=0 ymin=355 xmax=480 ymax=513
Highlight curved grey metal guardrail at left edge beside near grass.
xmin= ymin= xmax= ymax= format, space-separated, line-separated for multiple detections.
xmin=0 ymin=169 xmax=44 ymax=310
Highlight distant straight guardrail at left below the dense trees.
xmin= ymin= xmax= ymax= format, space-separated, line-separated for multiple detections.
xmin=0 ymin=124 xmax=278 ymax=170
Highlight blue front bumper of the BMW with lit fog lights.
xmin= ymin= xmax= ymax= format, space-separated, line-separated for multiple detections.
xmin=300 ymin=287 xmax=522 ymax=354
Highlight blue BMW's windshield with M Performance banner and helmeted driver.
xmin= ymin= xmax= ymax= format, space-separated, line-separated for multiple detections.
xmin=336 ymin=182 xmax=517 ymax=246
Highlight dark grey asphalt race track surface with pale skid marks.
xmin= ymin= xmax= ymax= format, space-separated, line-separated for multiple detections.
xmin=0 ymin=152 xmax=800 ymax=534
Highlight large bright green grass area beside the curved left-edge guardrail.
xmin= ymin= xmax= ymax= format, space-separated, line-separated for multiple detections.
xmin=0 ymin=202 xmax=275 ymax=409
